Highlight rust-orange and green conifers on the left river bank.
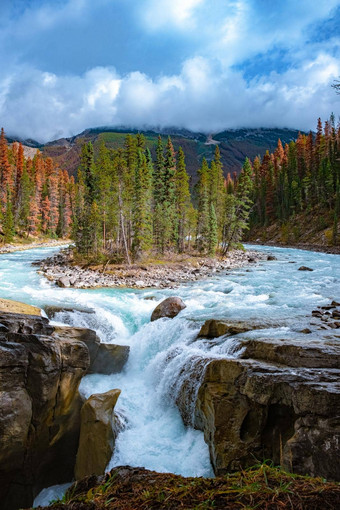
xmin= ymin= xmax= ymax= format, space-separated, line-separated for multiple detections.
xmin=0 ymin=129 xmax=75 ymax=242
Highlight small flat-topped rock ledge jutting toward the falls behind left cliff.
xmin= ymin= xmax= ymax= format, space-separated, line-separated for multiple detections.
xmin=54 ymin=326 xmax=130 ymax=374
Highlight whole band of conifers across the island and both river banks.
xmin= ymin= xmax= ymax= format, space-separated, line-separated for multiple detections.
xmin=0 ymin=116 xmax=340 ymax=256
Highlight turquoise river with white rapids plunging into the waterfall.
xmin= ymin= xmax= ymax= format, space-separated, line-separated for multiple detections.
xmin=0 ymin=246 xmax=340 ymax=504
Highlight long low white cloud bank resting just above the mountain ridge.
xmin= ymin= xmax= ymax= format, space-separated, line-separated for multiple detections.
xmin=0 ymin=53 xmax=340 ymax=141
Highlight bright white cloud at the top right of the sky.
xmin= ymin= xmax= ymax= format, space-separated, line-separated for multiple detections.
xmin=203 ymin=0 xmax=339 ymax=67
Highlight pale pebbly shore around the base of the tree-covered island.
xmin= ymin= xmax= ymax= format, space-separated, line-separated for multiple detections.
xmin=39 ymin=249 xmax=268 ymax=289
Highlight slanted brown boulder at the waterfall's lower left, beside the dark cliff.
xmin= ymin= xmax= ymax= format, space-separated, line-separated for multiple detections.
xmin=74 ymin=390 xmax=120 ymax=480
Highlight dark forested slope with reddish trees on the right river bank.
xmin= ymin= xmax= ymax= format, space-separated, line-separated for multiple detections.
xmin=250 ymin=115 xmax=340 ymax=245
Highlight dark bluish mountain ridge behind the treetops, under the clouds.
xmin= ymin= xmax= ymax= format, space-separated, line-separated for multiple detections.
xmin=17 ymin=128 xmax=299 ymax=181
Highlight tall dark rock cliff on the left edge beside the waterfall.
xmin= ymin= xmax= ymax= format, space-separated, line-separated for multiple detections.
xmin=0 ymin=304 xmax=89 ymax=510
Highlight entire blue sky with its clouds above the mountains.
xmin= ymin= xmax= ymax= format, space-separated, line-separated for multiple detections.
xmin=0 ymin=0 xmax=340 ymax=141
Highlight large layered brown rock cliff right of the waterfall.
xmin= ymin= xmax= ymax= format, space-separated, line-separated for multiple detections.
xmin=177 ymin=332 xmax=340 ymax=480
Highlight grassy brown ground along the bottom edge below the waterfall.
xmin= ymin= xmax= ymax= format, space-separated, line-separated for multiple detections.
xmin=30 ymin=465 xmax=340 ymax=510
